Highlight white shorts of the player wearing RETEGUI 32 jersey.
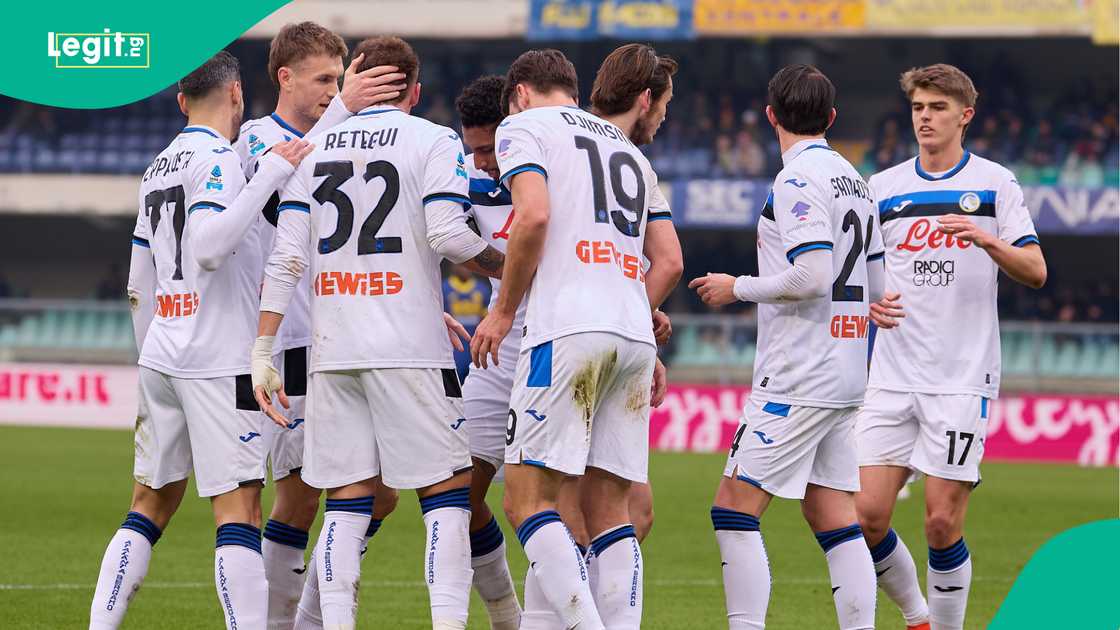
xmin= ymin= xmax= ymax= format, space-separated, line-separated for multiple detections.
xmin=301 ymin=368 xmax=470 ymax=490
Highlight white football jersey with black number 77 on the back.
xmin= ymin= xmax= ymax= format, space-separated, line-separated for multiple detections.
xmin=133 ymin=126 xmax=264 ymax=378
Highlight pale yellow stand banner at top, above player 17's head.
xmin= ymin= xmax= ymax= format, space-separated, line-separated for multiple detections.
xmin=867 ymin=0 xmax=1088 ymax=34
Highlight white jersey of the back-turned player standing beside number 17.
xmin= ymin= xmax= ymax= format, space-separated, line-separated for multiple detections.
xmin=750 ymin=139 xmax=883 ymax=408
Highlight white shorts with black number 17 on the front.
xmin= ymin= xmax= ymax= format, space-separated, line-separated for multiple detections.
xmin=856 ymin=387 xmax=990 ymax=483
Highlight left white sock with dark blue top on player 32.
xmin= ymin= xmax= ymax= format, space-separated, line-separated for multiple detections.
xmin=312 ymin=497 xmax=373 ymax=630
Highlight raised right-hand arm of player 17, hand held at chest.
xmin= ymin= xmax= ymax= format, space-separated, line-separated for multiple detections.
xmin=939 ymin=175 xmax=1046 ymax=289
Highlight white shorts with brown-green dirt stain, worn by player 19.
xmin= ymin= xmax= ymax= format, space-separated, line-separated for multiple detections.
xmin=505 ymin=332 xmax=656 ymax=483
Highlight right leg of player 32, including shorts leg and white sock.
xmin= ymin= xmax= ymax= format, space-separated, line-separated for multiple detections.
xmin=362 ymin=368 xmax=473 ymax=630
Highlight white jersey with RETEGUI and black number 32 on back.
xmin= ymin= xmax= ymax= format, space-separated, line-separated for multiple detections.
xmin=276 ymin=106 xmax=470 ymax=372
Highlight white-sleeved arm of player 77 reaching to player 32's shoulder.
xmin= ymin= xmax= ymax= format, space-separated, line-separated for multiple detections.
xmin=187 ymin=140 xmax=314 ymax=271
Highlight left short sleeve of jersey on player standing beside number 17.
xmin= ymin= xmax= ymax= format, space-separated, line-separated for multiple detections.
xmin=774 ymin=169 xmax=832 ymax=265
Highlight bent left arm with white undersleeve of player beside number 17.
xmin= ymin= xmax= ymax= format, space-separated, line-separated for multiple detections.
xmin=689 ymin=172 xmax=832 ymax=306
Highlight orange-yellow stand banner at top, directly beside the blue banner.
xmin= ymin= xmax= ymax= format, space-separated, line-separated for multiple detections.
xmin=692 ymin=0 xmax=867 ymax=35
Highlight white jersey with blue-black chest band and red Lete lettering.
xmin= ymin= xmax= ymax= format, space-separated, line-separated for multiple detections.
xmin=868 ymin=151 xmax=1038 ymax=398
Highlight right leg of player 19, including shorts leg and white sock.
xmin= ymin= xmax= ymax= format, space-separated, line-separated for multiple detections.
xmin=580 ymin=335 xmax=656 ymax=630
